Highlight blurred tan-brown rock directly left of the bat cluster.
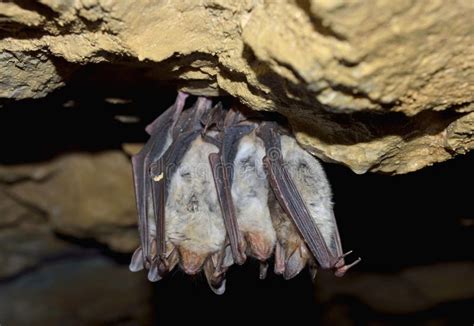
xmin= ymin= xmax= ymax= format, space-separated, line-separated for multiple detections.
xmin=0 ymin=151 xmax=138 ymax=252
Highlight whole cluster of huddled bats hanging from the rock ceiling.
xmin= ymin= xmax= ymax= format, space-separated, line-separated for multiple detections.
xmin=130 ymin=93 xmax=360 ymax=294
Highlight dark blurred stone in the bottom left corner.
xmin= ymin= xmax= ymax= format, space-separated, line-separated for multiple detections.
xmin=0 ymin=257 xmax=151 ymax=326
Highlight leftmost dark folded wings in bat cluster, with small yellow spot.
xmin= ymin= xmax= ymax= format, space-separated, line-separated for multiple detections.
xmin=130 ymin=93 xmax=210 ymax=281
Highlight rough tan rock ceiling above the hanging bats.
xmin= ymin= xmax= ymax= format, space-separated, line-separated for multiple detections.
xmin=0 ymin=0 xmax=474 ymax=173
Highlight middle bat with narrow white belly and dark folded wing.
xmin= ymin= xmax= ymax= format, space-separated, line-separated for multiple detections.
xmin=209 ymin=110 xmax=276 ymax=266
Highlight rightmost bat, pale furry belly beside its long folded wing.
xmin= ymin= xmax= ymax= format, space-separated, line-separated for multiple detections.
xmin=258 ymin=122 xmax=361 ymax=276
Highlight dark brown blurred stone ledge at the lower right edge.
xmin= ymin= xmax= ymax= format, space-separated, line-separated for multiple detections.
xmin=316 ymin=262 xmax=474 ymax=314
